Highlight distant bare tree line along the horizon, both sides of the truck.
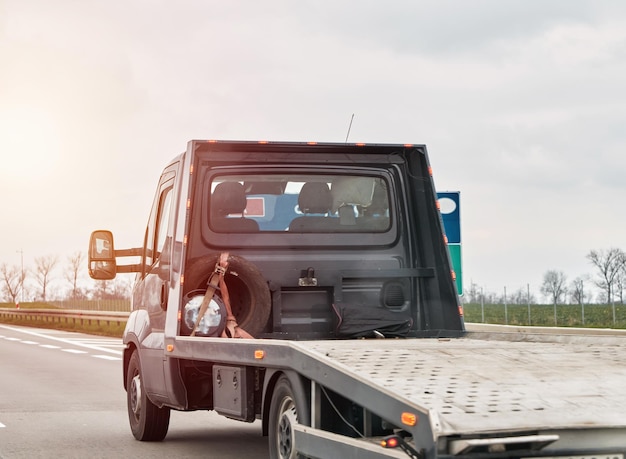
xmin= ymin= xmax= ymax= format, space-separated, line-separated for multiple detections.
xmin=0 ymin=248 xmax=626 ymax=305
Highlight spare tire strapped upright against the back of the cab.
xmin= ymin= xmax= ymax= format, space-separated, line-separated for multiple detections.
xmin=183 ymin=254 xmax=272 ymax=337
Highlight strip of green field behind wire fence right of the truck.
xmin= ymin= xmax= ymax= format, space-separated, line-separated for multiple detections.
xmin=463 ymin=303 xmax=626 ymax=328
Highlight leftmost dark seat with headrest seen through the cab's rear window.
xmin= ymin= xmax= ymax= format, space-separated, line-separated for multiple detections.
xmin=210 ymin=182 xmax=259 ymax=233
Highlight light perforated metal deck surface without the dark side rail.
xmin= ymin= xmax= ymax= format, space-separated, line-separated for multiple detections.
xmin=300 ymin=338 xmax=626 ymax=435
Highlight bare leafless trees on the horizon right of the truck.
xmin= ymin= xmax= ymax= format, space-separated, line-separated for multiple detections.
xmin=464 ymin=248 xmax=626 ymax=305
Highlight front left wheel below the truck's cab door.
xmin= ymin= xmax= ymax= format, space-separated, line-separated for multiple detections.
xmin=126 ymin=351 xmax=170 ymax=441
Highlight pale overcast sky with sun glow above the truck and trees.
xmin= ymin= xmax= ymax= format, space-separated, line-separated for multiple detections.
xmin=0 ymin=0 xmax=626 ymax=300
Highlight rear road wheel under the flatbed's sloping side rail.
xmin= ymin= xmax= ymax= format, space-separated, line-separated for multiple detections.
xmin=268 ymin=375 xmax=310 ymax=459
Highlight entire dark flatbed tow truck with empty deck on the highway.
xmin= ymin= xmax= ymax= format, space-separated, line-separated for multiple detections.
xmin=89 ymin=141 xmax=626 ymax=459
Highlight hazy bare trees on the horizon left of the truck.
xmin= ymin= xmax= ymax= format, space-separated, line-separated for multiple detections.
xmin=0 ymin=251 xmax=131 ymax=303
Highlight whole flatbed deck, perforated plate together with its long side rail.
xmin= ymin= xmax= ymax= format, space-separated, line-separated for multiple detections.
xmin=173 ymin=334 xmax=626 ymax=444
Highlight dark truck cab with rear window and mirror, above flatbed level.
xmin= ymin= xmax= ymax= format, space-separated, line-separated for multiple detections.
xmin=90 ymin=141 xmax=463 ymax=339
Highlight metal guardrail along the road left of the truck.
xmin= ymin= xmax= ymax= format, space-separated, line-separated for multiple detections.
xmin=0 ymin=308 xmax=129 ymax=325
